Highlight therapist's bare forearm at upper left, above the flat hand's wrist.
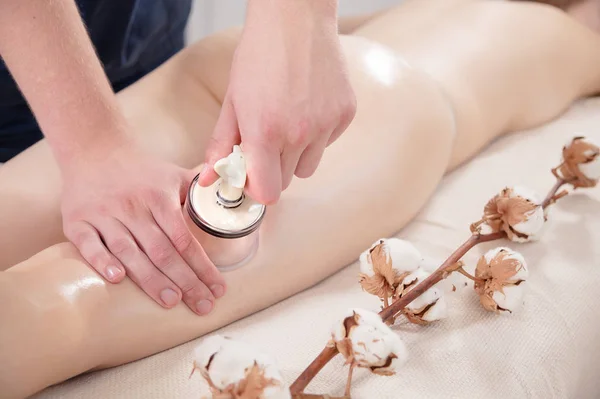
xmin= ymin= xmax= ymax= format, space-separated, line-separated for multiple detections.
xmin=0 ymin=0 xmax=125 ymax=166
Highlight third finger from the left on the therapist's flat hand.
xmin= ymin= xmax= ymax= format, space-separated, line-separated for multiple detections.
xmin=125 ymin=206 xmax=215 ymax=315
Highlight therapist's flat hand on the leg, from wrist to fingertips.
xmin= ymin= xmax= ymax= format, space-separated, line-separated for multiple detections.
xmin=62 ymin=147 xmax=225 ymax=315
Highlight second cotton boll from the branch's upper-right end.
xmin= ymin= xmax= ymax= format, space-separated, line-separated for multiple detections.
xmin=471 ymin=186 xmax=546 ymax=242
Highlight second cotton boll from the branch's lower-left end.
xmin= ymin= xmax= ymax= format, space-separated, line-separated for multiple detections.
xmin=331 ymin=309 xmax=408 ymax=375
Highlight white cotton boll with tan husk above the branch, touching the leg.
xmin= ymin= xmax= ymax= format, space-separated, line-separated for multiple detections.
xmin=359 ymin=238 xmax=423 ymax=299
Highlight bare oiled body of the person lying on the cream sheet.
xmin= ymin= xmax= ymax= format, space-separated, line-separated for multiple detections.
xmin=0 ymin=0 xmax=600 ymax=397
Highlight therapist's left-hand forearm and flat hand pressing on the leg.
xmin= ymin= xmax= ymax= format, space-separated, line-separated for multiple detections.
xmin=0 ymin=0 xmax=224 ymax=314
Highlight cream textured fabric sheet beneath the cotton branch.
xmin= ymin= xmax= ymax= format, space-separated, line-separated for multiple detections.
xmin=36 ymin=99 xmax=600 ymax=399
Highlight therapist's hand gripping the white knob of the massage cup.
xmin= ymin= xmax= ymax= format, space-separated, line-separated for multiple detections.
xmin=200 ymin=0 xmax=356 ymax=204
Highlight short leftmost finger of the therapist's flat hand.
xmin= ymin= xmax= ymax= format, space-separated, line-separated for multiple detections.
xmin=65 ymin=222 xmax=125 ymax=283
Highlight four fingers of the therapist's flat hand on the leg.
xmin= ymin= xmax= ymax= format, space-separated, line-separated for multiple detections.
xmin=65 ymin=180 xmax=225 ymax=315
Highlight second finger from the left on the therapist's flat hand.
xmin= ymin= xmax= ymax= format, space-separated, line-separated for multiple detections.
xmin=94 ymin=218 xmax=182 ymax=309
